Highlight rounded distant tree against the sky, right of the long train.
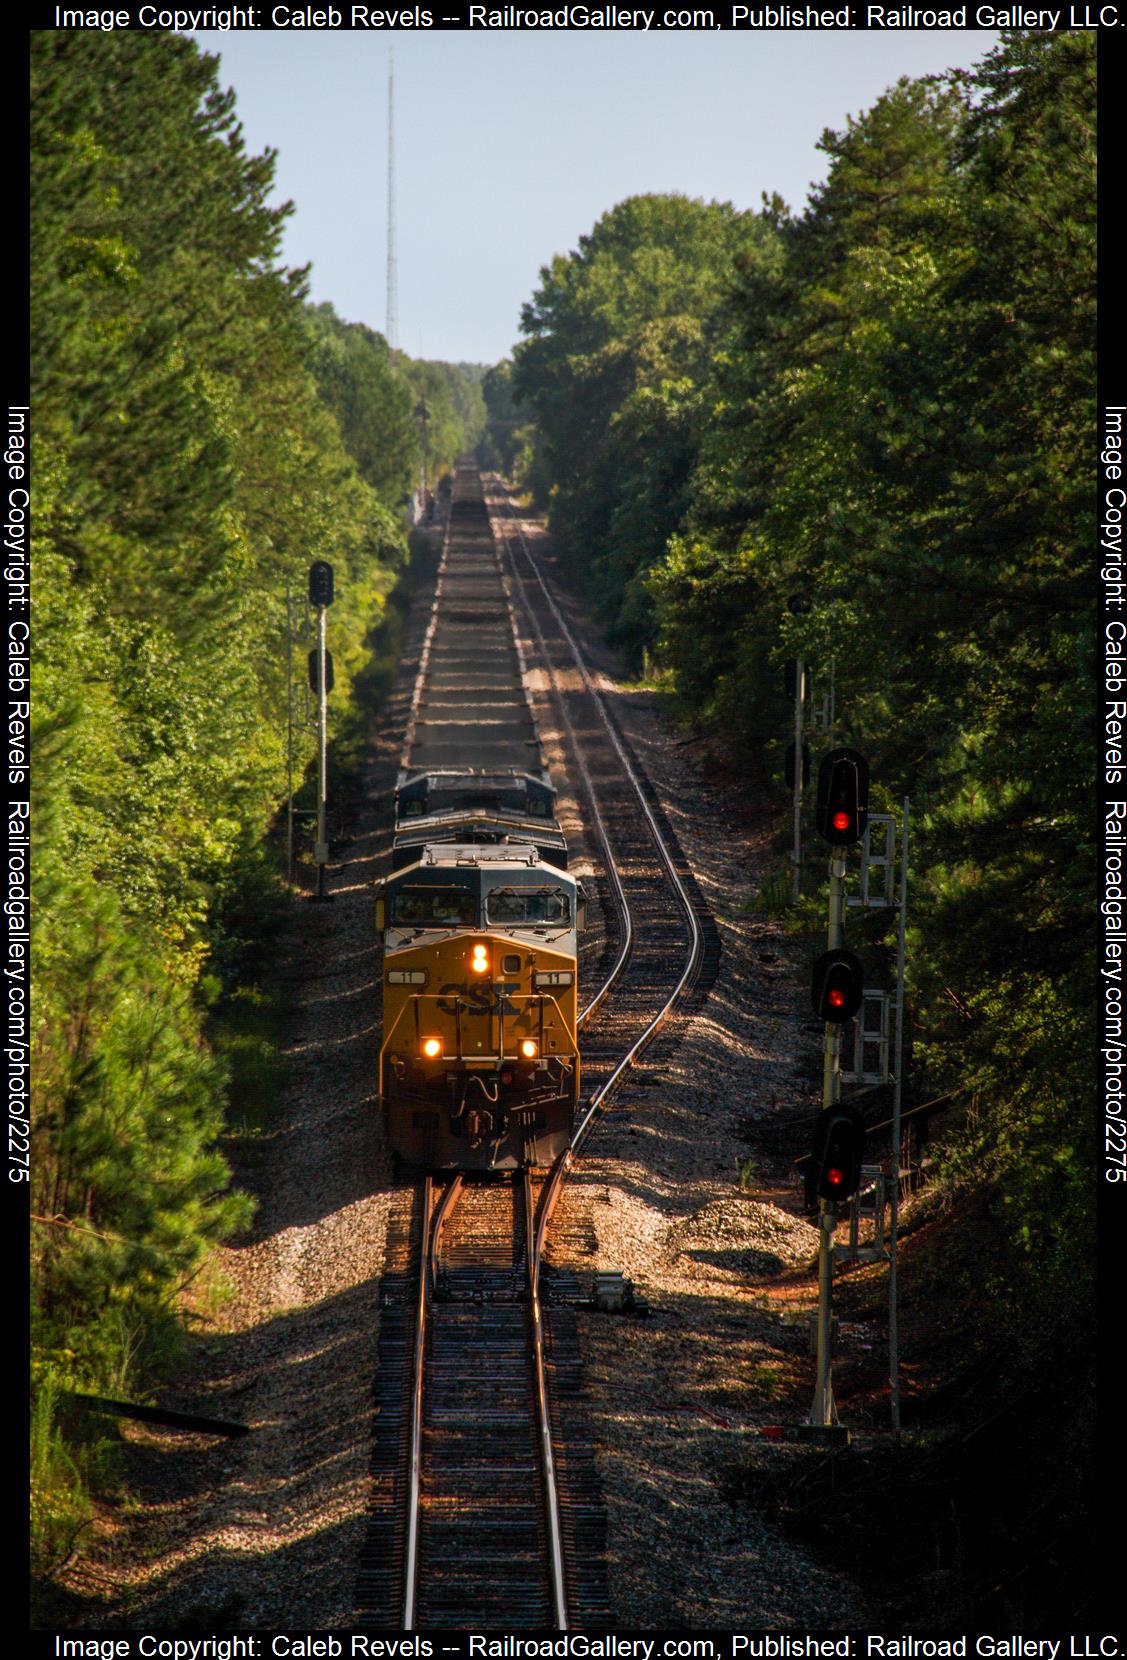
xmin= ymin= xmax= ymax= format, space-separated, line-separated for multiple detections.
xmin=513 ymin=196 xmax=770 ymax=646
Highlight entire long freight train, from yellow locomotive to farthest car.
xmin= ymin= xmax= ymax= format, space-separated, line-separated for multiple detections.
xmin=377 ymin=466 xmax=584 ymax=1170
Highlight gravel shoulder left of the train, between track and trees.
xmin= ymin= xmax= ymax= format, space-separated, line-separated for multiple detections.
xmin=73 ymin=534 xmax=437 ymax=1632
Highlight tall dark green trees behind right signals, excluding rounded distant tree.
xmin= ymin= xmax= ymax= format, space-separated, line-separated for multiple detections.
xmin=652 ymin=33 xmax=1095 ymax=1306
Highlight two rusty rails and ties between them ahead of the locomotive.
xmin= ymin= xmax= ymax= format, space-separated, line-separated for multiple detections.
xmin=403 ymin=1172 xmax=568 ymax=1630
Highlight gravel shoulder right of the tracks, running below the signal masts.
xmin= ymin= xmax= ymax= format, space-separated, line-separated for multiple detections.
xmin=523 ymin=520 xmax=870 ymax=1630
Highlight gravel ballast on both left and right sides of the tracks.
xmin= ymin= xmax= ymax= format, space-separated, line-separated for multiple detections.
xmin=90 ymin=498 xmax=870 ymax=1633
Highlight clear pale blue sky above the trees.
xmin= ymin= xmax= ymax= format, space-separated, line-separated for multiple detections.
xmin=194 ymin=30 xmax=998 ymax=364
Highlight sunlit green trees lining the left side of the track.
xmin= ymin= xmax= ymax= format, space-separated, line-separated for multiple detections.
xmin=32 ymin=32 xmax=481 ymax=1565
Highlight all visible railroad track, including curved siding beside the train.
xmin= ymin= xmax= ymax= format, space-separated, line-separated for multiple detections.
xmin=359 ymin=471 xmax=717 ymax=1630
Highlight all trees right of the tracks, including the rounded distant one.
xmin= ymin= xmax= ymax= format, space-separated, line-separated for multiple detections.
xmin=516 ymin=32 xmax=1095 ymax=1336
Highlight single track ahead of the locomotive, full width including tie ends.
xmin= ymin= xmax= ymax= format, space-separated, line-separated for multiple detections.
xmin=359 ymin=1172 xmax=607 ymax=1630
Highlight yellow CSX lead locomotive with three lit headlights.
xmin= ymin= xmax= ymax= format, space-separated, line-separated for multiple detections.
xmin=377 ymin=842 xmax=584 ymax=1170
